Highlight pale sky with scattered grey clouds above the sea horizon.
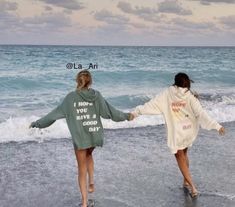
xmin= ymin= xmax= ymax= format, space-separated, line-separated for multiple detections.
xmin=0 ymin=0 xmax=235 ymax=46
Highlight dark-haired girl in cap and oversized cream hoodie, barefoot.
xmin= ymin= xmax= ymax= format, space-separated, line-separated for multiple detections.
xmin=133 ymin=73 xmax=225 ymax=197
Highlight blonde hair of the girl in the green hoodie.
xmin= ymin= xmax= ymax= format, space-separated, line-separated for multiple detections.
xmin=76 ymin=70 xmax=92 ymax=90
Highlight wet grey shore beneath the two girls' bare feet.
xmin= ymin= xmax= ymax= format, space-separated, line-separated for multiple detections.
xmin=0 ymin=122 xmax=235 ymax=207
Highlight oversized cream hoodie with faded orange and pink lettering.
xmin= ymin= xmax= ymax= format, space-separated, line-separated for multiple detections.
xmin=133 ymin=86 xmax=222 ymax=154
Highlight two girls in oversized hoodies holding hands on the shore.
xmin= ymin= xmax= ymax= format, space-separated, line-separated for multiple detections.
xmin=31 ymin=70 xmax=224 ymax=207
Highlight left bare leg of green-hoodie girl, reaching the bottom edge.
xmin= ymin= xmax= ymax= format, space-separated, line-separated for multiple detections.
xmin=75 ymin=149 xmax=88 ymax=207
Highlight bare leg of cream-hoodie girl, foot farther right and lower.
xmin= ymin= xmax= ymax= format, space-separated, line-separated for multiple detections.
xmin=175 ymin=150 xmax=197 ymax=194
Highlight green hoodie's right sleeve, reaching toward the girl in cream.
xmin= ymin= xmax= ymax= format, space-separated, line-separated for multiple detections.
xmin=99 ymin=93 xmax=129 ymax=122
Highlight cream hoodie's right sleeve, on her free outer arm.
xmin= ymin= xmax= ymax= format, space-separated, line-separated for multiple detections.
xmin=191 ymin=95 xmax=222 ymax=131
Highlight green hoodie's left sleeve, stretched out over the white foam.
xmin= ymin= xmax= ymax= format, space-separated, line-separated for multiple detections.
xmin=31 ymin=99 xmax=66 ymax=128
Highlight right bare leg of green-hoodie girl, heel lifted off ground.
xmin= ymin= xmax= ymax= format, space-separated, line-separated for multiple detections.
xmin=87 ymin=147 xmax=95 ymax=193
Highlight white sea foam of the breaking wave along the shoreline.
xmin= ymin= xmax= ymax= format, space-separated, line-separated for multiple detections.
xmin=0 ymin=102 xmax=235 ymax=143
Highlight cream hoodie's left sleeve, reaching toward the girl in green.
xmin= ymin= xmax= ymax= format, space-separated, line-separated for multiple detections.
xmin=133 ymin=92 xmax=165 ymax=116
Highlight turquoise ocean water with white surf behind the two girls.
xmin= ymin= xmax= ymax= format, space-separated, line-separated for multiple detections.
xmin=0 ymin=45 xmax=235 ymax=143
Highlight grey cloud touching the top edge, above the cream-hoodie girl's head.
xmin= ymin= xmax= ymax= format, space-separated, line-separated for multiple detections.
xmin=158 ymin=0 xmax=192 ymax=15
